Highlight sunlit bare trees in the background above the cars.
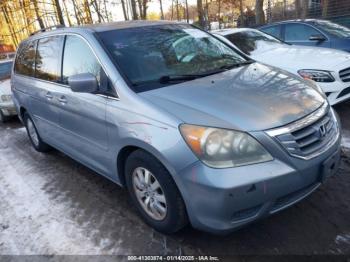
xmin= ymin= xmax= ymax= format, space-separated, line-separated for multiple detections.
xmin=0 ymin=0 xmax=350 ymax=47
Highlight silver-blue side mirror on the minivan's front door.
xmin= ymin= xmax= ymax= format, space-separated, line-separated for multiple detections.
xmin=68 ymin=73 xmax=98 ymax=93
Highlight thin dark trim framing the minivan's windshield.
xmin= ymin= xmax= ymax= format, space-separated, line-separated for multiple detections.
xmin=93 ymin=23 xmax=256 ymax=94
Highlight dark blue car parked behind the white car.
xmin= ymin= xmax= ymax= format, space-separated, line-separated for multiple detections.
xmin=258 ymin=19 xmax=350 ymax=52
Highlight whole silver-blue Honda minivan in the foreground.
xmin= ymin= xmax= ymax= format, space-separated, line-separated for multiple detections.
xmin=12 ymin=21 xmax=340 ymax=233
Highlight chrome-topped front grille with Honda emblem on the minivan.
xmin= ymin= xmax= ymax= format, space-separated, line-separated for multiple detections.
xmin=267 ymin=106 xmax=339 ymax=159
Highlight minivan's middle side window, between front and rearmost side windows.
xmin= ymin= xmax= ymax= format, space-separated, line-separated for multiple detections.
xmin=35 ymin=36 xmax=64 ymax=82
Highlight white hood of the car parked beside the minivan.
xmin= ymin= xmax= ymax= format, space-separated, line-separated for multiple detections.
xmin=250 ymin=41 xmax=350 ymax=71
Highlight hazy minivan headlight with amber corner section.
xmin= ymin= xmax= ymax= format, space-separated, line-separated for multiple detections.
xmin=180 ymin=124 xmax=273 ymax=168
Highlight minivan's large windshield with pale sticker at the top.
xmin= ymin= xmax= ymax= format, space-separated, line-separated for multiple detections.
xmin=98 ymin=24 xmax=250 ymax=92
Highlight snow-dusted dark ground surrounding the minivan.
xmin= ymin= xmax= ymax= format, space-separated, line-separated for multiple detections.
xmin=0 ymin=102 xmax=350 ymax=255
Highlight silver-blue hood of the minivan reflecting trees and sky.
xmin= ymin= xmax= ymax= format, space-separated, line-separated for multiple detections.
xmin=140 ymin=63 xmax=325 ymax=131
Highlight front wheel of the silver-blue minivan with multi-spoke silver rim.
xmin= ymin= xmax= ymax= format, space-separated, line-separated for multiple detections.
xmin=125 ymin=150 xmax=187 ymax=233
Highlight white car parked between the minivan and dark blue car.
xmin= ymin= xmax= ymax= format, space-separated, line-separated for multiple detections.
xmin=213 ymin=28 xmax=350 ymax=105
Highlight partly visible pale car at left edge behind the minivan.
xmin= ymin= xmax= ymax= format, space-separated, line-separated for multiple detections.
xmin=0 ymin=60 xmax=17 ymax=122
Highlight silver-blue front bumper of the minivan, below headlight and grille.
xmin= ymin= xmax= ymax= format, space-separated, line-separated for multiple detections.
xmin=178 ymin=133 xmax=340 ymax=234
